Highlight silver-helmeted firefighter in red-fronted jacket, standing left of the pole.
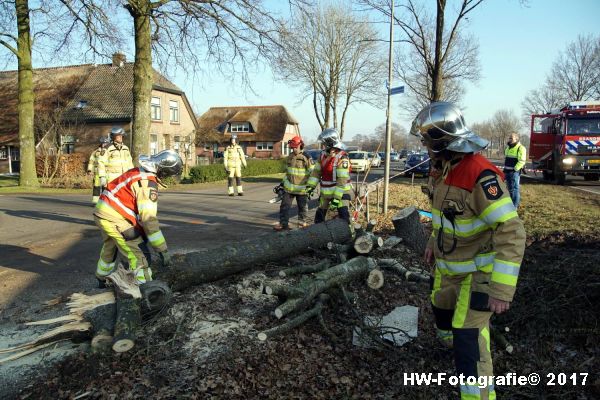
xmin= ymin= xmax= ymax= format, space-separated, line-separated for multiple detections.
xmin=307 ymin=128 xmax=352 ymax=224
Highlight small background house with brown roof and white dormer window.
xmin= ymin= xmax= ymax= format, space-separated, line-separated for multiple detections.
xmin=196 ymin=105 xmax=300 ymax=159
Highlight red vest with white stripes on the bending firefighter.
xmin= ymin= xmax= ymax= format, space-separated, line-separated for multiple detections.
xmin=100 ymin=168 xmax=158 ymax=233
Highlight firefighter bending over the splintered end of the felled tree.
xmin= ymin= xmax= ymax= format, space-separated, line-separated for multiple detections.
xmin=94 ymin=150 xmax=183 ymax=287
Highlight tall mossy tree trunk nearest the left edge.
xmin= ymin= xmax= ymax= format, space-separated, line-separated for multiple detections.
xmin=15 ymin=0 xmax=40 ymax=187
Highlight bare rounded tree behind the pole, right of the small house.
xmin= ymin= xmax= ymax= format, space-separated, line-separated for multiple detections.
xmin=274 ymin=3 xmax=385 ymax=137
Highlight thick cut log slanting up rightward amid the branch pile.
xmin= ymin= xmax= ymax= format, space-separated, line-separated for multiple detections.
xmin=275 ymin=256 xmax=376 ymax=319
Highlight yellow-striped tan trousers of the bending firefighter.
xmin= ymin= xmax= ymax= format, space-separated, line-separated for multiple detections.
xmin=94 ymin=216 xmax=152 ymax=284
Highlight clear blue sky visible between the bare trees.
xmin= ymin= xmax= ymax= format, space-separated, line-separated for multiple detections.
xmin=4 ymin=0 xmax=600 ymax=144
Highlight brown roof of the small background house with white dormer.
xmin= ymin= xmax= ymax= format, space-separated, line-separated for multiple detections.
xmin=197 ymin=105 xmax=298 ymax=143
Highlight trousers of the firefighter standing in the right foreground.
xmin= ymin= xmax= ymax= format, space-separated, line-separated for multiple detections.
xmin=431 ymin=268 xmax=496 ymax=400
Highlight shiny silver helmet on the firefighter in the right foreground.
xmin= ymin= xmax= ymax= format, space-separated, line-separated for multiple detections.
xmin=410 ymin=101 xmax=489 ymax=153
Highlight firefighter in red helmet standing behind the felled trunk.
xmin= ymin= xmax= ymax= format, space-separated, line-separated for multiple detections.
xmin=274 ymin=136 xmax=313 ymax=231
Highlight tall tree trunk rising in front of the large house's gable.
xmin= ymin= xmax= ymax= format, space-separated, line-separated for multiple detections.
xmin=128 ymin=0 xmax=152 ymax=160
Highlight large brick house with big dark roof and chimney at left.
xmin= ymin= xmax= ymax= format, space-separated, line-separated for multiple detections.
xmin=0 ymin=53 xmax=198 ymax=173
